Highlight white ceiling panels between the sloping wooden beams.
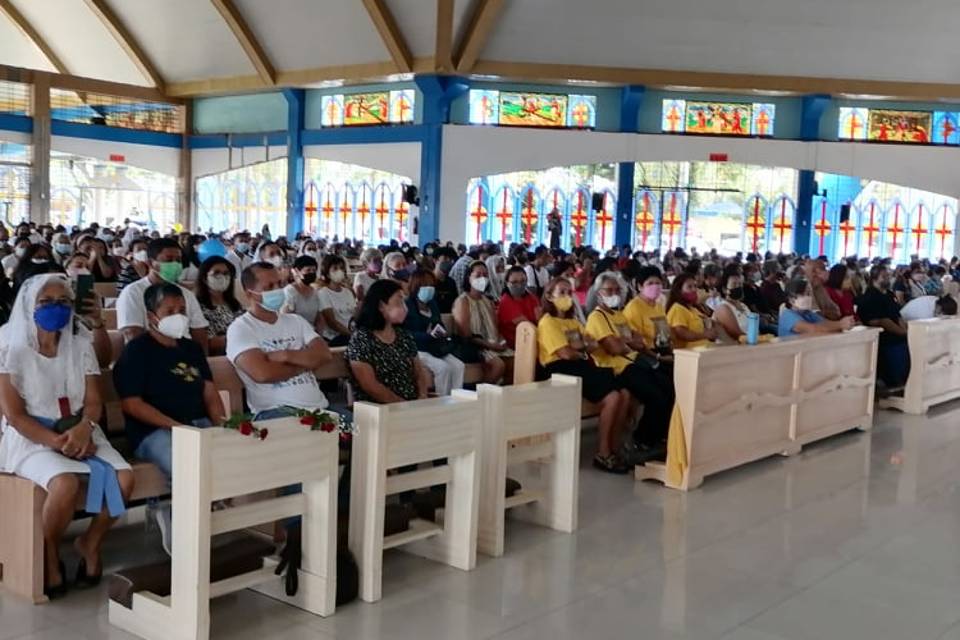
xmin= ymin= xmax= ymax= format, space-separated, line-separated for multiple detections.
xmin=0 ymin=0 xmax=960 ymax=92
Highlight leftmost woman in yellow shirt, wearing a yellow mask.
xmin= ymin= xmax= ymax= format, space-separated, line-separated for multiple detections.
xmin=537 ymin=278 xmax=630 ymax=473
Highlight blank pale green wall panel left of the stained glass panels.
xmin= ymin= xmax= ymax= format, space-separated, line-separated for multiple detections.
xmin=193 ymin=92 xmax=287 ymax=133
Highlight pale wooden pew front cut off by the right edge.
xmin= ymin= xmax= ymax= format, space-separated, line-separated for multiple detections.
xmin=880 ymin=318 xmax=960 ymax=414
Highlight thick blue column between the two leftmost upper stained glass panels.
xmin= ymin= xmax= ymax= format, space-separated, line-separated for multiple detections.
xmin=414 ymin=75 xmax=469 ymax=247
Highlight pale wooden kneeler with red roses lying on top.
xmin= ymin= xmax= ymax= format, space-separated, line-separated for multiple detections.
xmin=109 ymin=418 xmax=339 ymax=640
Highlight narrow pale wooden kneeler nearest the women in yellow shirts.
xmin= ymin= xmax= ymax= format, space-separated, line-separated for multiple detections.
xmin=477 ymin=375 xmax=581 ymax=556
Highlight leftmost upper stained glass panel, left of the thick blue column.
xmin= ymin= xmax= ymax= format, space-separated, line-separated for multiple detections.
xmin=320 ymin=89 xmax=416 ymax=127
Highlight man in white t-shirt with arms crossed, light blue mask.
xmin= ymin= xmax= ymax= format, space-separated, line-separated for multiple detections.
xmin=227 ymin=262 xmax=332 ymax=420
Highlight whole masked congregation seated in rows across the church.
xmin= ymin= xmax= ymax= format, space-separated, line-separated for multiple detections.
xmin=0 ymin=218 xmax=960 ymax=616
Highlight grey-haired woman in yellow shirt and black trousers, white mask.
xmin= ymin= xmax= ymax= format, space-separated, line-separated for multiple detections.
xmin=587 ymin=276 xmax=674 ymax=464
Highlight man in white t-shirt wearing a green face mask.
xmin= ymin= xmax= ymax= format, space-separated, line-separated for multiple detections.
xmin=117 ymin=238 xmax=208 ymax=353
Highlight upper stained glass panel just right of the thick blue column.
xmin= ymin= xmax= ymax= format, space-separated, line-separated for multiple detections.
xmin=469 ymin=89 xmax=597 ymax=129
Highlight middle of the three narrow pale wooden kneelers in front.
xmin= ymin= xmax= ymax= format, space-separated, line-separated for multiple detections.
xmin=349 ymin=390 xmax=482 ymax=602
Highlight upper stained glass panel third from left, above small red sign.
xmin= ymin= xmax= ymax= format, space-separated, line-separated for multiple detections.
xmin=660 ymin=99 xmax=777 ymax=137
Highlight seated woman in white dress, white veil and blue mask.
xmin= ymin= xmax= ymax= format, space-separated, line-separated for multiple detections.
xmin=0 ymin=274 xmax=133 ymax=597
